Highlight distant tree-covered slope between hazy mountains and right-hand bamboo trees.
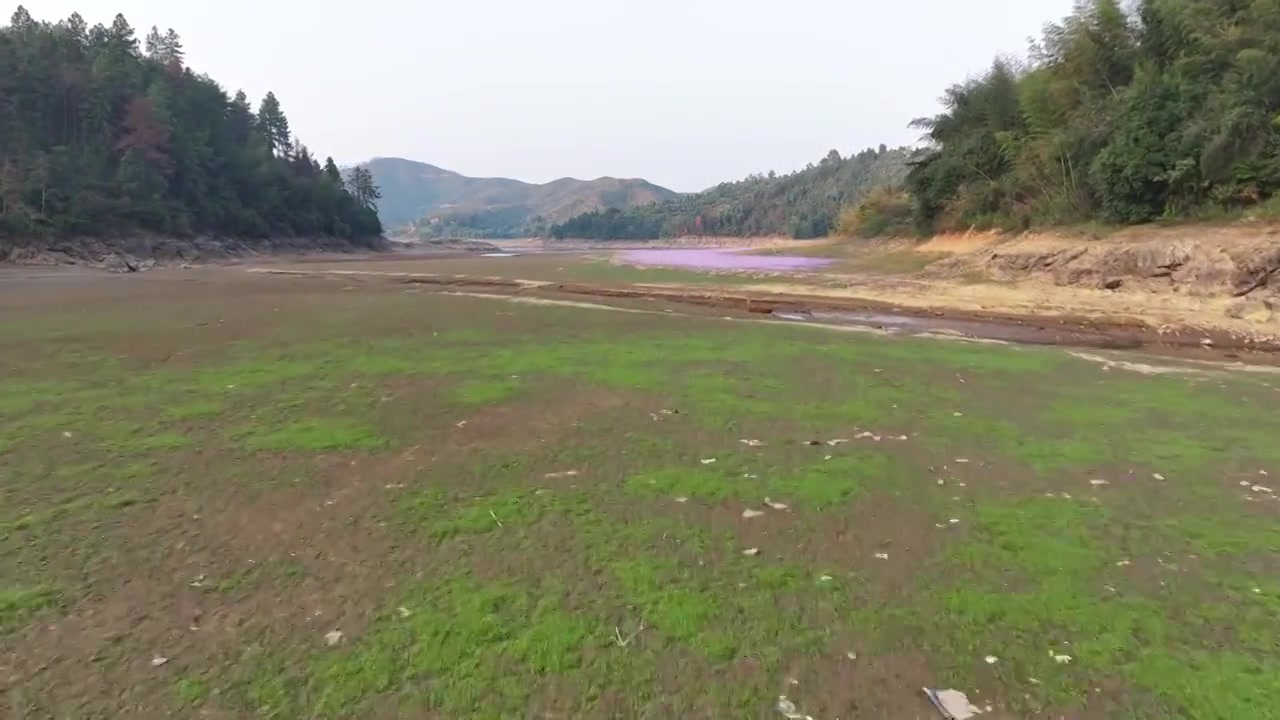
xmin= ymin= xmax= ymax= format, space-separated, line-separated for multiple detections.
xmin=550 ymin=145 xmax=910 ymax=240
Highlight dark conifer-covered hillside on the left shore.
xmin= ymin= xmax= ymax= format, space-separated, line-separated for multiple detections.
xmin=0 ymin=6 xmax=381 ymax=246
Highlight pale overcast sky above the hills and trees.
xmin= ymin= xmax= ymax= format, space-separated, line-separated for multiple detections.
xmin=32 ymin=0 xmax=1071 ymax=192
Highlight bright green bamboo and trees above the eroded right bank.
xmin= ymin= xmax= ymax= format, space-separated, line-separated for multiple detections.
xmin=906 ymin=0 xmax=1280 ymax=232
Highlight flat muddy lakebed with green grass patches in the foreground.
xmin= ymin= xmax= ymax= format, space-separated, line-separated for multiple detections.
xmin=0 ymin=260 xmax=1280 ymax=720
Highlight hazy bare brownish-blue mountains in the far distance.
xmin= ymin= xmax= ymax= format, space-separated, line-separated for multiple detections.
xmin=364 ymin=158 xmax=680 ymax=237
